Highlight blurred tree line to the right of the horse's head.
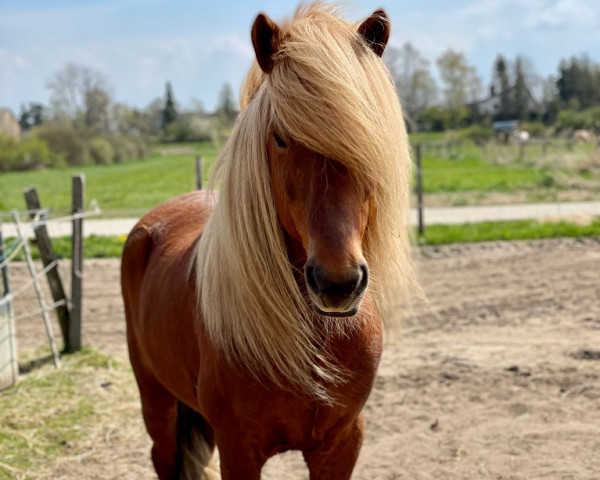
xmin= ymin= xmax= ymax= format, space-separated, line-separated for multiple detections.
xmin=384 ymin=42 xmax=600 ymax=132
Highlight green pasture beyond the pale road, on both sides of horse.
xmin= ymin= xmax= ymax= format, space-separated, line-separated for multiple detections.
xmin=0 ymin=134 xmax=600 ymax=218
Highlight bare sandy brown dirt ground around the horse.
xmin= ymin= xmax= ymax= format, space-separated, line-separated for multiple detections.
xmin=11 ymin=238 xmax=600 ymax=480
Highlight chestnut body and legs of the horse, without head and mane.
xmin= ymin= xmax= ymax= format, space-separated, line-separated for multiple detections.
xmin=123 ymin=192 xmax=381 ymax=479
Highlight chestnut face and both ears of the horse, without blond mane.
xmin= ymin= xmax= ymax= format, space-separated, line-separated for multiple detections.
xmin=247 ymin=10 xmax=389 ymax=316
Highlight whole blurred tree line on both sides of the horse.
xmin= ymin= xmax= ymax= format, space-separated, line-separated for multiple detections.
xmin=5 ymin=47 xmax=600 ymax=171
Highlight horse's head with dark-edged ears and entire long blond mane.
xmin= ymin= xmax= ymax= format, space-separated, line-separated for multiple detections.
xmin=195 ymin=1 xmax=412 ymax=400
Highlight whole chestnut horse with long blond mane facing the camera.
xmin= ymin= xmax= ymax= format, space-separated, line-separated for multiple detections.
xmin=121 ymin=3 xmax=413 ymax=480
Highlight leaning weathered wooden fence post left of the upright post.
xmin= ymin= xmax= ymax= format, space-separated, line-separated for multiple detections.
xmin=23 ymin=188 xmax=70 ymax=352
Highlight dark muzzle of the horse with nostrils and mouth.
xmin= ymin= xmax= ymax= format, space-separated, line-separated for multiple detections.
xmin=304 ymin=258 xmax=369 ymax=317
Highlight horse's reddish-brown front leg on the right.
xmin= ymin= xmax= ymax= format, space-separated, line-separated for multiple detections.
xmin=303 ymin=413 xmax=365 ymax=480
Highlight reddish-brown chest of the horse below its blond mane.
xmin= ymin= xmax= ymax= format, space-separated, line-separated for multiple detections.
xmin=198 ymin=322 xmax=381 ymax=457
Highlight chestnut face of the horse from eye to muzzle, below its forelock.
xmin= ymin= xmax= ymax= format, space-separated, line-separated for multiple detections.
xmin=267 ymin=132 xmax=373 ymax=316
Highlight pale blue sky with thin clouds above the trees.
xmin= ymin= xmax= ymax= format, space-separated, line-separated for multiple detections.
xmin=0 ymin=0 xmax=600 ymax=114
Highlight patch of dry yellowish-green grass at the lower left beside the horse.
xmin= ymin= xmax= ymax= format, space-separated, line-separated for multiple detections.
xmin=0 ymin=349 xmax=143 ymax=479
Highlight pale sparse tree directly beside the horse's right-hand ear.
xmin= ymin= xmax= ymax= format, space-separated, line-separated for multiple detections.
xmin=384 ymin=42 xmax=437 ymax=126
